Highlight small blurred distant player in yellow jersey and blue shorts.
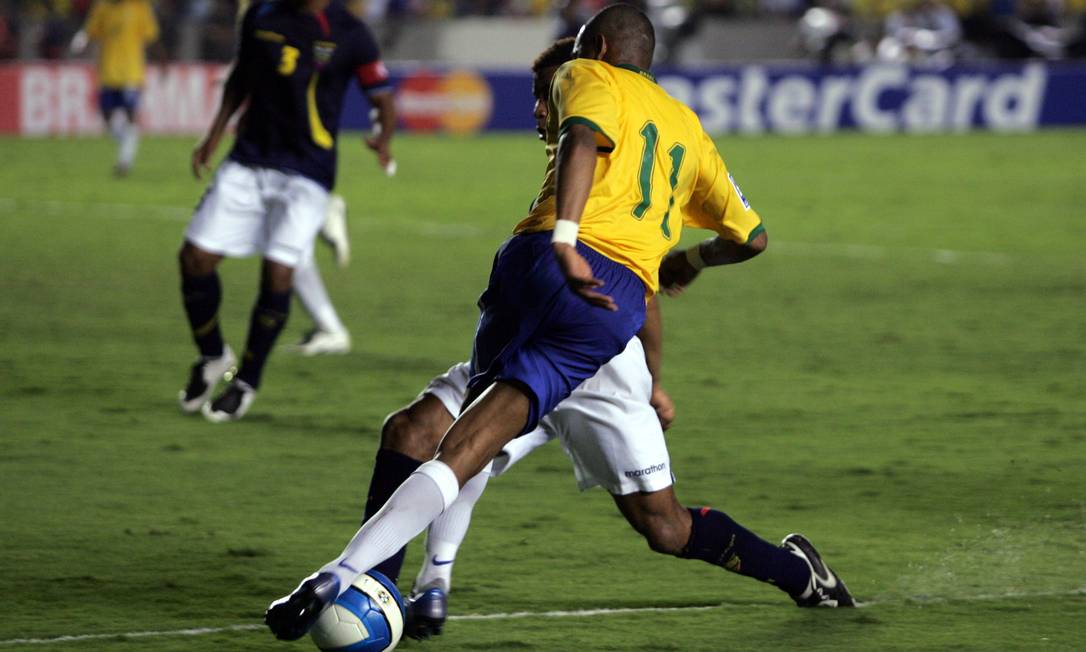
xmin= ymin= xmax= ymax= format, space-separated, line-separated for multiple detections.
xmin=71 ymin=0 xmax=159 ymax=176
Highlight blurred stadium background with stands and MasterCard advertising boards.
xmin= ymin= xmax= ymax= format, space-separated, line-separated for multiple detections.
xmin=6 ymin=0 xmax=1086 ymax=135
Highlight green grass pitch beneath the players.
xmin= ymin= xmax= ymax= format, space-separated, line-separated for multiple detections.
xmin=0 ymin=131 xmax=1086 ymax=651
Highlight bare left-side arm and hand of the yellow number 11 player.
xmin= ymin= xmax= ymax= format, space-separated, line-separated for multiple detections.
xmin=554 ymin=125 xmax=618 ymax=311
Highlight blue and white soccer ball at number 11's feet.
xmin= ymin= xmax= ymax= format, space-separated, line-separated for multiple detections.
xmin=310 ymin=571 xmax=404 ymax=652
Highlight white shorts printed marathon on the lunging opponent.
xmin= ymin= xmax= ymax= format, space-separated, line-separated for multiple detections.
xmin=419 ymin=338 xmax=672 ymax=496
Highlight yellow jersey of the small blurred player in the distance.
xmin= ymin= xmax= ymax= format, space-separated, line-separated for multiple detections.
xmin=86 ymin=0 xmax=159 ymax=88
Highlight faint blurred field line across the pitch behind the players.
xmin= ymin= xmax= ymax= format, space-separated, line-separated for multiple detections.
xmin=0 ymin=197 xmax=1014 ymax=265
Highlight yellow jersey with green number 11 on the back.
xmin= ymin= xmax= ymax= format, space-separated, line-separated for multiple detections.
xmin=514 ymin=59 xmax=763 ymax=294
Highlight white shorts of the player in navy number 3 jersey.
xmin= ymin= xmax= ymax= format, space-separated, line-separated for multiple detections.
xmin=185 ymin=160 xmax=328 ymax=267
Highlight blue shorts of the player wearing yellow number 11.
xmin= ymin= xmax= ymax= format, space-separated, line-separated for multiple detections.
xmin=468 ymin=231 xmax=645 ymax=434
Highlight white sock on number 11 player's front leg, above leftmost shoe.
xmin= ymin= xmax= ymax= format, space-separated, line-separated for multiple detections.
xmin=320 ymin=460 xmax=459 ymax=593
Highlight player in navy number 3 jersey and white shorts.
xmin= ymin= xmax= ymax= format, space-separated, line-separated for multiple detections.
xmin=179 ymin=0 xmax=395 ymax=422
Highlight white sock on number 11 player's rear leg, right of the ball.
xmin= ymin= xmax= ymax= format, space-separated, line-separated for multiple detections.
xmin=412 ymin=472 xmax=490 ymax=593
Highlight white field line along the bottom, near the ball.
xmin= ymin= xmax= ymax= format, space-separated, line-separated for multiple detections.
xmin=0 ymin=587 xmax=1086 ymax=648
